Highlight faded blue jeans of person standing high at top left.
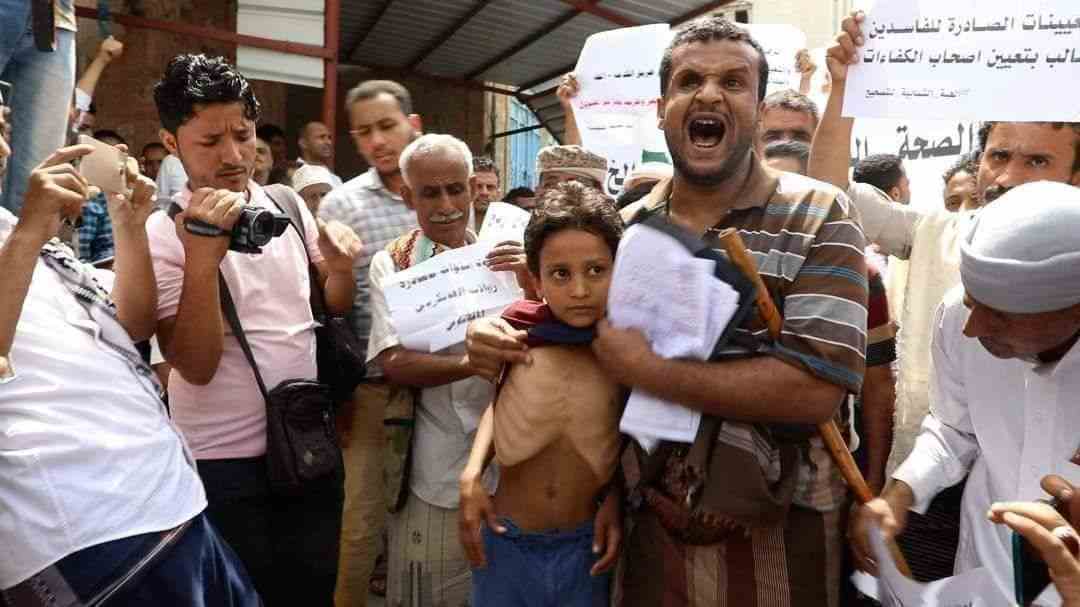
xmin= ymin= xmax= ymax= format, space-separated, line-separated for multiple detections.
xmin=0 ymin=0 xmax=76 ymax=215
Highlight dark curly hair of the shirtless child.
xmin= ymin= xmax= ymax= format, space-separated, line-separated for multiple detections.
xmin=525 ymin=181 xmax=623 ymax=275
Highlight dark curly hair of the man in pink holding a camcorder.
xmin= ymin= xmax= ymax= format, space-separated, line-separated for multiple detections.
xmin=153 ymin=54 xmax=259 ymax=135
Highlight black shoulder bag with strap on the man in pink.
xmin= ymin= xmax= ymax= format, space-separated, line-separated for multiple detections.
xmin=168 ymin=203 xmax=343 ymax=495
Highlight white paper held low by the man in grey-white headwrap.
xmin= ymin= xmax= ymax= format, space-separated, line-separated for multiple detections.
xmin=852 ymin=526 xmax=1012 ymax=607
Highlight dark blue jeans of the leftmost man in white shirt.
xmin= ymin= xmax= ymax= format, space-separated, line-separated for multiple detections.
xmin=3 ymin=514 xmax=261 ymax=607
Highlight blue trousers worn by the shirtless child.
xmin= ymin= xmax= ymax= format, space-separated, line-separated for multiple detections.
xmin=472 ymin=518 xmax=611 ymax=607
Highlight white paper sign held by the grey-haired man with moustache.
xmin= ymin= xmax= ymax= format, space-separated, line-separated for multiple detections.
xmin=382 ymin=243 xmax=522 ymax=352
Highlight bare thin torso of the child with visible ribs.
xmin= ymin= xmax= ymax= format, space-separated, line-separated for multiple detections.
xmin=495 ymin=346 xmax=621 ymax=530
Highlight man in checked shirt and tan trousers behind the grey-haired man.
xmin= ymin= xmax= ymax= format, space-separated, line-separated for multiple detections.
xmin=319 ymin=80 xmax=421 ymax=607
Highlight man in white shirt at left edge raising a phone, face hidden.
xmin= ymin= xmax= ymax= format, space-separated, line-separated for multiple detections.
xmin=0 ymin=99 xmax=259 ymax=607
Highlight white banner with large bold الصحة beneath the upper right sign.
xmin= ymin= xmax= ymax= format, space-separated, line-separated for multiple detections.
xmin=851 ymin=119 xmax=980 ymax=211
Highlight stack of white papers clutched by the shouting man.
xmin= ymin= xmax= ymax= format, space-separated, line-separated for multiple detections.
xmin=608 ymin=225 xmax=739 ymax=450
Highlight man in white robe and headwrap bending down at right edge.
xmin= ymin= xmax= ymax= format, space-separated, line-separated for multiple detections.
xmin=851 ymin=181 xmax=1080 ymax=605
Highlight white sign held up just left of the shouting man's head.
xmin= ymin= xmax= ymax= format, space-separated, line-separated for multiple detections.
xmin=573 ymin=24 xmax=672 ymax=195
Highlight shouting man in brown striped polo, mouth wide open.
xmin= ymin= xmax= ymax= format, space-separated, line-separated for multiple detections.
xmin=469 ymin=16 xmax=867 ymax=607
